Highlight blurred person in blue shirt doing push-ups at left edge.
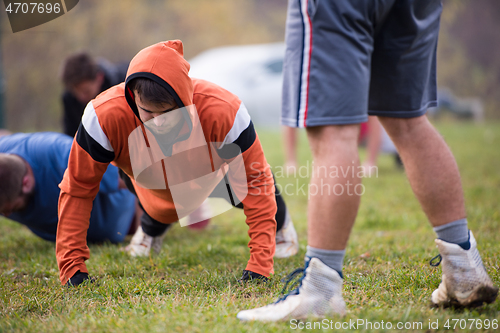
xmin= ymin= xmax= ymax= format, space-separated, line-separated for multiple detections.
xmin=0 ymin=132 xmax=140 ymax=243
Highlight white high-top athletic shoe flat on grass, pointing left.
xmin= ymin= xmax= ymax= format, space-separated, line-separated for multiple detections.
xmin=237 ymin=258 xmax=346 ymax=321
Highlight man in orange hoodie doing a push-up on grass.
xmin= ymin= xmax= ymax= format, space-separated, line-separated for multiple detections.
xmin=56 ymin=40 xmax=298 ymax=285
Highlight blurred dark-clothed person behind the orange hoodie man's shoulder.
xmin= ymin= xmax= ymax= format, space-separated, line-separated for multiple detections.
xmin=62 ymin=52 xmax=128 ymax=137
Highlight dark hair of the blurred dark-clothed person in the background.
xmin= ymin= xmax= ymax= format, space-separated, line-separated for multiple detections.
xmin=62 ymin=53 xmax=101 ymax=89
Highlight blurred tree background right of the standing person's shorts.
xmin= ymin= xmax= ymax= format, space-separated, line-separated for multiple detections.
xmin=438 ymin=0 xmax=500 ymax=119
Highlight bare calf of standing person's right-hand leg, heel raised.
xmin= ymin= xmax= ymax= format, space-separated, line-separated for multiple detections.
xmin=379 ymin=116 xmax=468 ymax=227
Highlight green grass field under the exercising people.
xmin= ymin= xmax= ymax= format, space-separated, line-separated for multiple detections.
xmin=0 ymin=123 xmax=500 ymax=333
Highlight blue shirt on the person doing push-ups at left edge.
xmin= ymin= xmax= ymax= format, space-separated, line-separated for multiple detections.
xmin=0 ymin=132 xmax=135 ymax=243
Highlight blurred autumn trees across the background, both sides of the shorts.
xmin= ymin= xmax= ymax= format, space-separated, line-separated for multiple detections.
xmin=0 ymin=0 xmax=500 ymax=131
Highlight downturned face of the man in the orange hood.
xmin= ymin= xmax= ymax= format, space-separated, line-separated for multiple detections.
xmin=134 ymin=91 xmax=182 ymax=134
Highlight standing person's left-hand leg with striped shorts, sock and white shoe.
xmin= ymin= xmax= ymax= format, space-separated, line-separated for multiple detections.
xmin=238 ymin=0 xmax=376 ymax=321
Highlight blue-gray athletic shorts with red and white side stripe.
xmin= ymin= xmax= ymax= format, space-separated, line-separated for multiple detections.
xmin=281 ymin=0 xmax=442 ymax=127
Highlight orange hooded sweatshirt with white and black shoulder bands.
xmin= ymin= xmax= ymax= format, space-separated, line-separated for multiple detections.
xmin=56 ymin=40 xmax=276 ymax=284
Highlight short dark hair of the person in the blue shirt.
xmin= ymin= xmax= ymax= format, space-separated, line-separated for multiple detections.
xmin=0 ymin=154 xmax=26 ymax=208
